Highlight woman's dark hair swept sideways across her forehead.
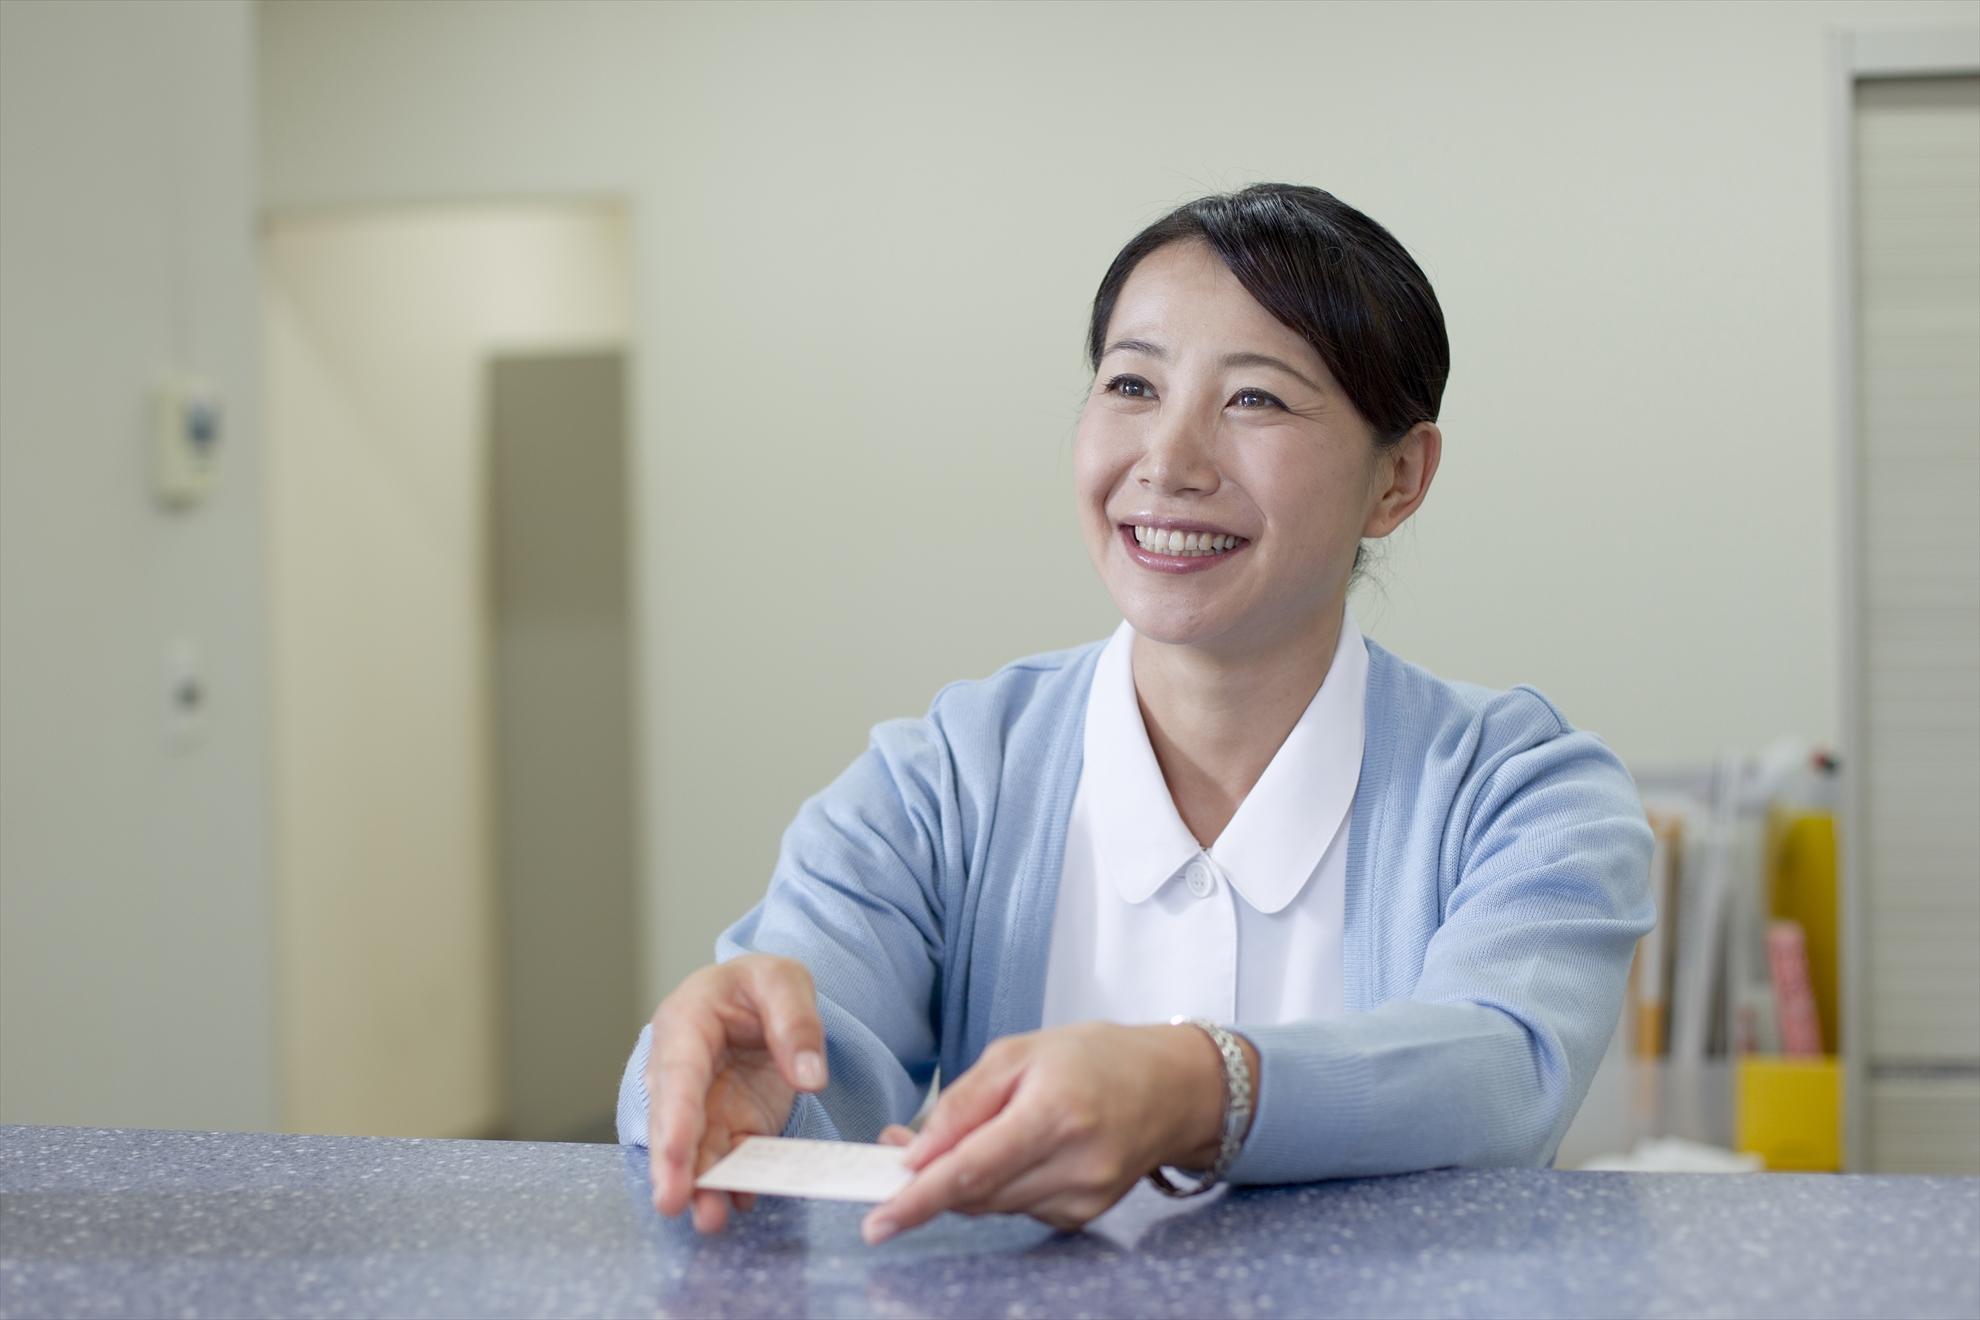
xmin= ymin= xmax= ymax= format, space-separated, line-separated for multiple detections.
xmin=1087 ymin=184 xmax=1451 ymax=445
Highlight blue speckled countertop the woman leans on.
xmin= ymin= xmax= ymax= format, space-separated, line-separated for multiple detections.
xmin=0 ymin=1128 xmax=1980 ymax=1316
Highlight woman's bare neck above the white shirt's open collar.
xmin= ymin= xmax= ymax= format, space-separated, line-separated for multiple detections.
xmin=1133 ymin=602 xmax=1344 ymax=847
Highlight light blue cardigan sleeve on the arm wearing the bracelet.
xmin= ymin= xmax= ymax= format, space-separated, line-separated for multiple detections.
xmin=1232 ymin=689 xmax=1655 ymax=1183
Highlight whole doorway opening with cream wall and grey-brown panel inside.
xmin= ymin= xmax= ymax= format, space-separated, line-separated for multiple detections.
xmin=263 ymin=204 xmax=640 ymax=1140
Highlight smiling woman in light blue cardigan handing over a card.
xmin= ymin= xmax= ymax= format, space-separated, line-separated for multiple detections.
xmin=620 ymin=184 xmax=1651 ymax=1241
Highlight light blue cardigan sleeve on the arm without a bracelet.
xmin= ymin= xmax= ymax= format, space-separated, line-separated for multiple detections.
xmin=618 ymin=718 xmax=960 ymax=1146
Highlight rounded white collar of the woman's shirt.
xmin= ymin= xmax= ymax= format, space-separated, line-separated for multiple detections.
xmin=1081 ymin=612 xmax=1368 ymax=912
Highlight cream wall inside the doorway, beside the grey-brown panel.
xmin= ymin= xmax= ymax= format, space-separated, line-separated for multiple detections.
xmin=263 ymin=206 xmax=630 ymax=1136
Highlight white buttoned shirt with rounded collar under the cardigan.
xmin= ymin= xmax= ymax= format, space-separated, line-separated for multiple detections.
xmin=1043 ymin=612 xmax=1368 ymax=1027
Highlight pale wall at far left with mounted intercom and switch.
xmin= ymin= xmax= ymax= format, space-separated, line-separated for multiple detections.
xmin=0 ymin=0 xmax=277 ymax=1128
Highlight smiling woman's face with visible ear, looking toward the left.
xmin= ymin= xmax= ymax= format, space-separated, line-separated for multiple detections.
xmin=1073 ymin=241 xmax=1434 ymax=657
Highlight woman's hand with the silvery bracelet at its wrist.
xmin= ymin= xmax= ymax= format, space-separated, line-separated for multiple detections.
xmin=863 ymin=1023 xmax=1255 ymax=1243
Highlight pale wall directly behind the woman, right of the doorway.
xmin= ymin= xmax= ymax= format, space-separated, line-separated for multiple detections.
xmin=261 ymin=0 xmax=1970 ymax=995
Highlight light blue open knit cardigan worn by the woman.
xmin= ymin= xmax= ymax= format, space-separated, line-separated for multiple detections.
xmin=618 ymin=641 xmax=1653 ymax=1183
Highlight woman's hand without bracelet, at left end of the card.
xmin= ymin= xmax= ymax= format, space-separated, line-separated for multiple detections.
xmin=645 ymin=954 xmax=826 ymax=1233
